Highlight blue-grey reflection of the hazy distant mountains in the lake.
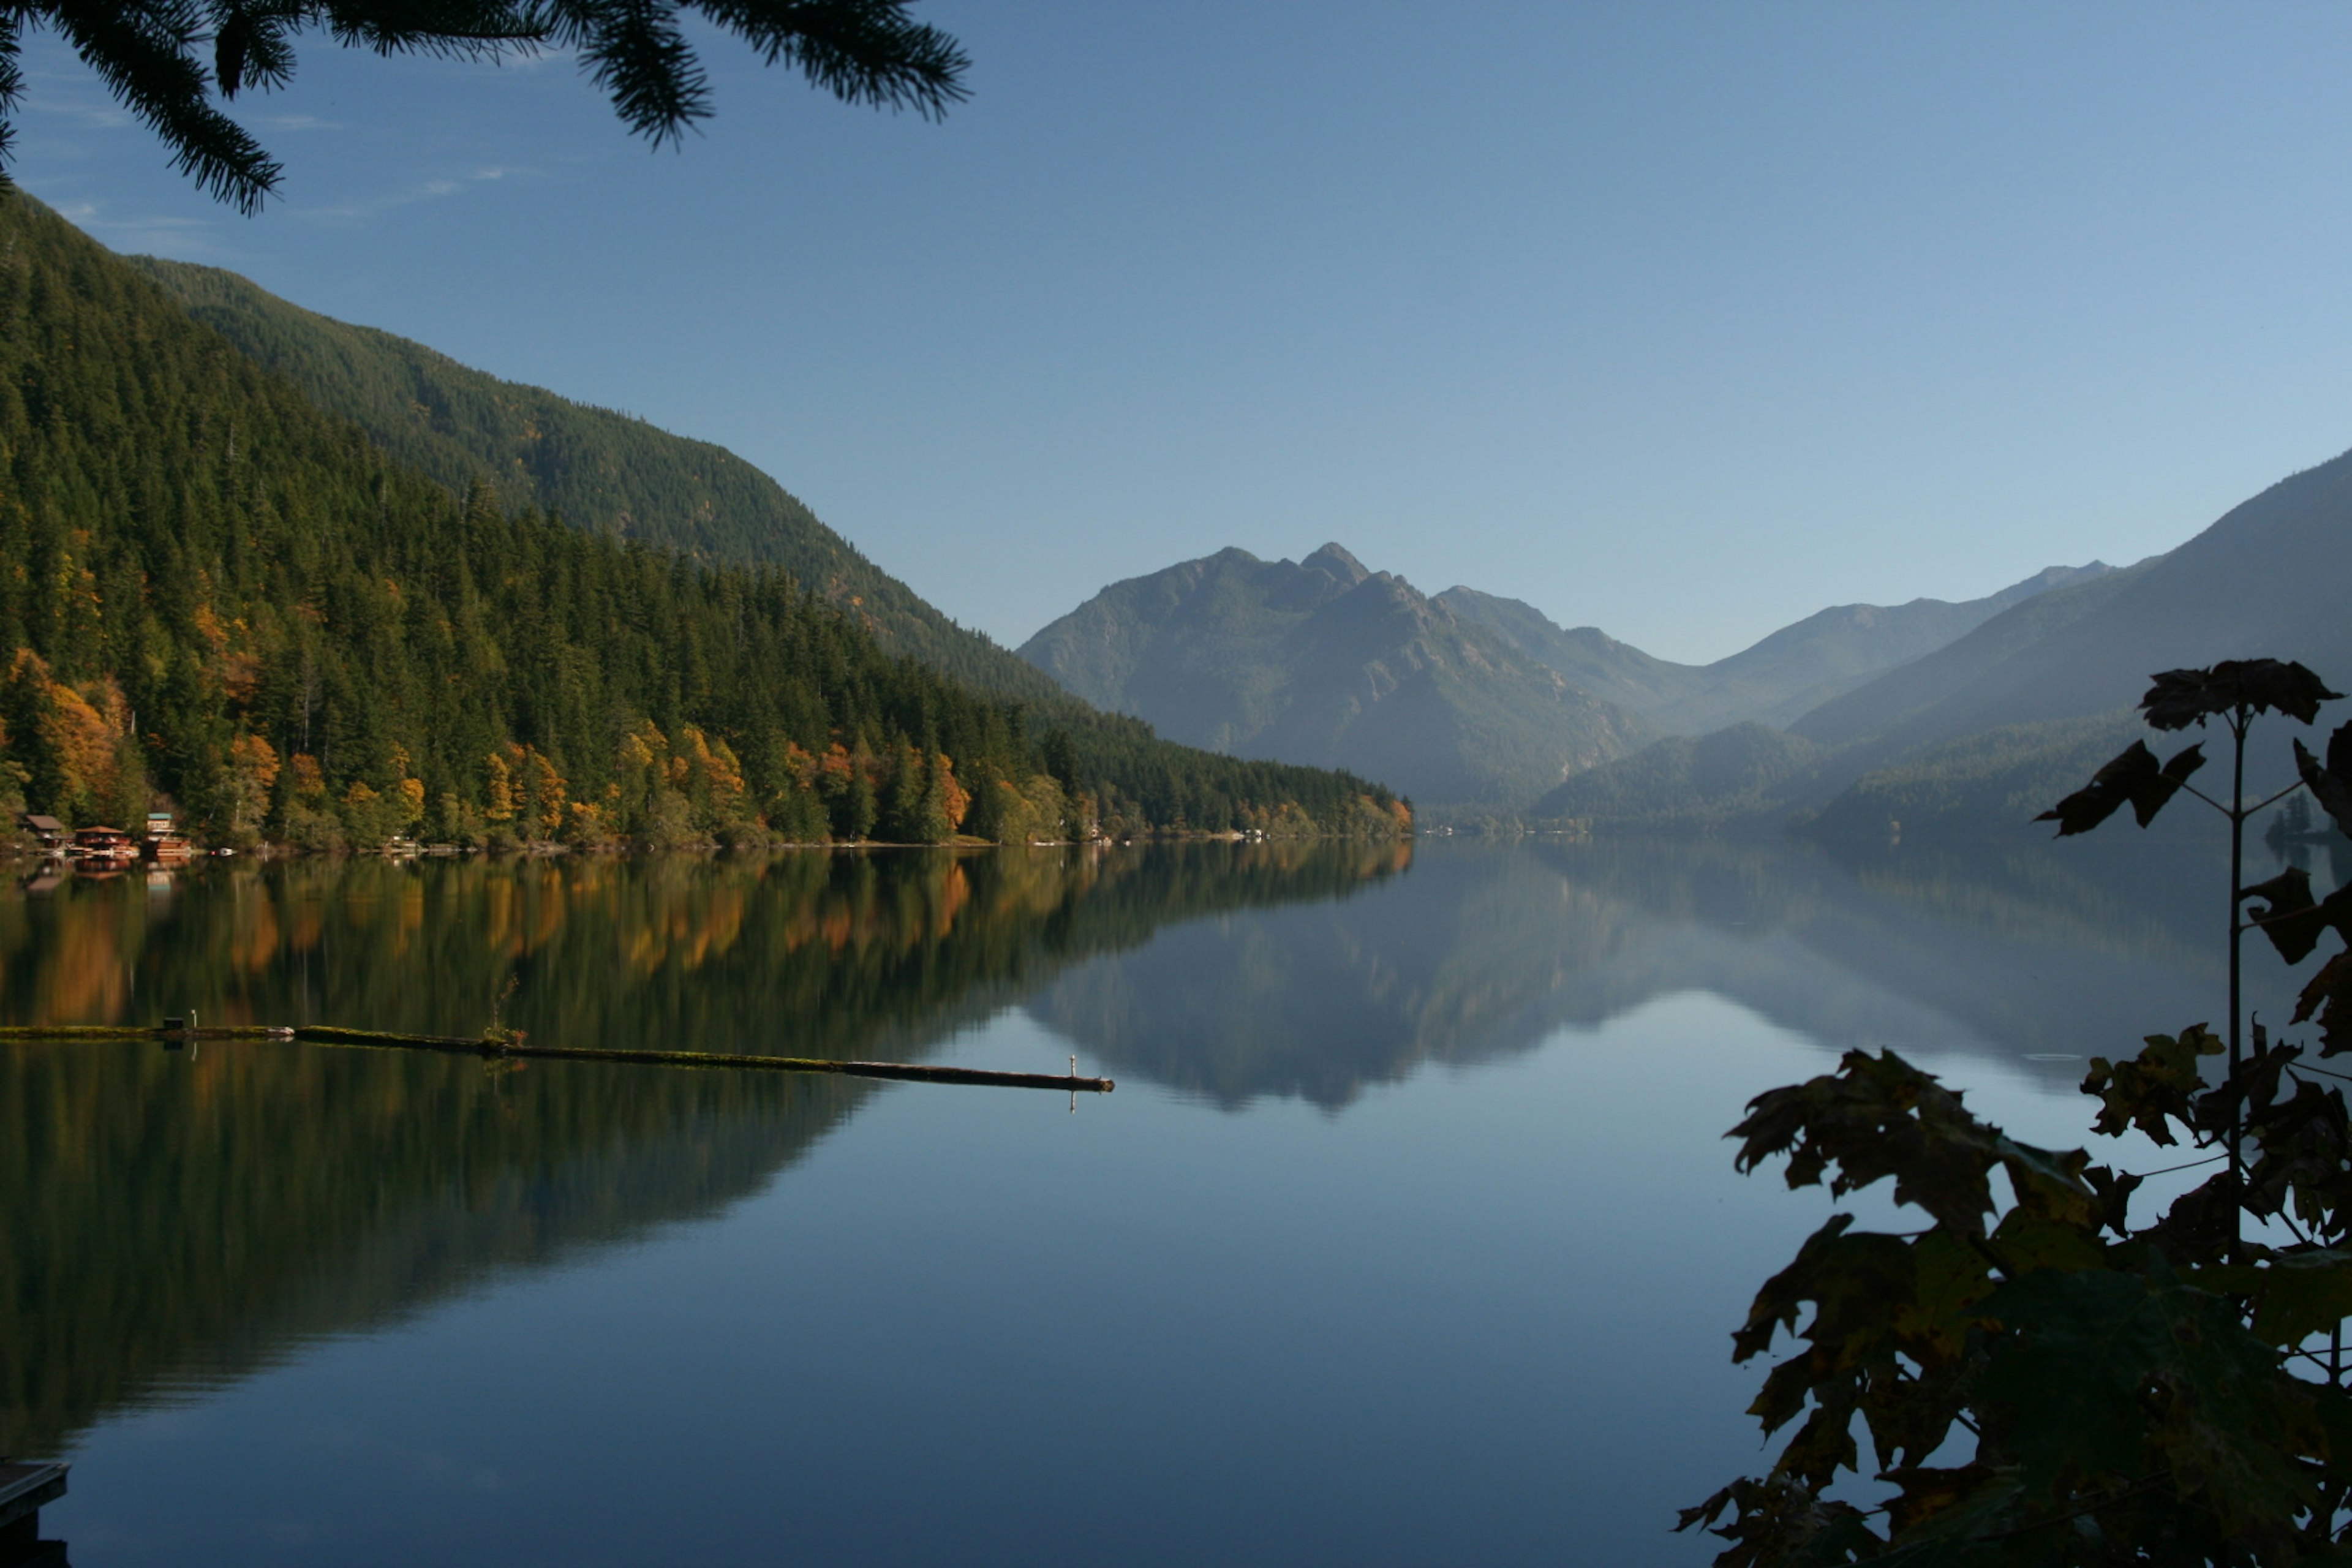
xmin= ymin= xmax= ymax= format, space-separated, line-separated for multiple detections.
xmin=1028 ymin=839 xmax=2345 ymax=1107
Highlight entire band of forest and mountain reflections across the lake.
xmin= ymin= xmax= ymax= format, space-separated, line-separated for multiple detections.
xmin=0 ymin=842 xmax=2340 ymax=1453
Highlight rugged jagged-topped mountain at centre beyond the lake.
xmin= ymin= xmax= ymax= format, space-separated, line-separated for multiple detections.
xmin=1021 ymin=545 xmax=1649 ymax=804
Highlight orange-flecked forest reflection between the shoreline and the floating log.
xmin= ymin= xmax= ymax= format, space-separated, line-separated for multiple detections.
xmin=0 ymin=844 xmax=1409 ymax=1058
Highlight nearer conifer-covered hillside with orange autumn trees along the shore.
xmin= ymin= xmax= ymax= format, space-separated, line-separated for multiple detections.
xmin=0 ymin=195 xmax=1404 ymax=844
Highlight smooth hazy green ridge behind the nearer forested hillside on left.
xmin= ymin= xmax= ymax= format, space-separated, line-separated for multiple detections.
xmin=125 ymin=256 xmax=1054 ymax=698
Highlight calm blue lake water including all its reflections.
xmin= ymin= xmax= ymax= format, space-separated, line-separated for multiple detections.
xmin=0 ymin=830 xmax=2340 ymax=1568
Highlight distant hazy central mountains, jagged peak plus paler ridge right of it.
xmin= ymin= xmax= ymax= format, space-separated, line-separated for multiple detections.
xmin=1021 ymin=543 xmax=2117 ymax=811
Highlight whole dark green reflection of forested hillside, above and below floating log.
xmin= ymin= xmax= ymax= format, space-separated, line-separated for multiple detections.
xmin=0 ymin=846 xmax=1402 ymax=1453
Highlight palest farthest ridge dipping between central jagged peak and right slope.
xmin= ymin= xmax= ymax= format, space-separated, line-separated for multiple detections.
xmin=1437 ymin=562 xmax=2109 ymax=736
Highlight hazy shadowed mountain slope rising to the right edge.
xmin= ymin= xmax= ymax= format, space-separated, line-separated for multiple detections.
xmin=1534 ymin=442 xmax=2352 ymax=835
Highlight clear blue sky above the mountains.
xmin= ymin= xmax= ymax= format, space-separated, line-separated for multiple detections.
xmin=14 ymin=0 xmax=2352 ymax=661
